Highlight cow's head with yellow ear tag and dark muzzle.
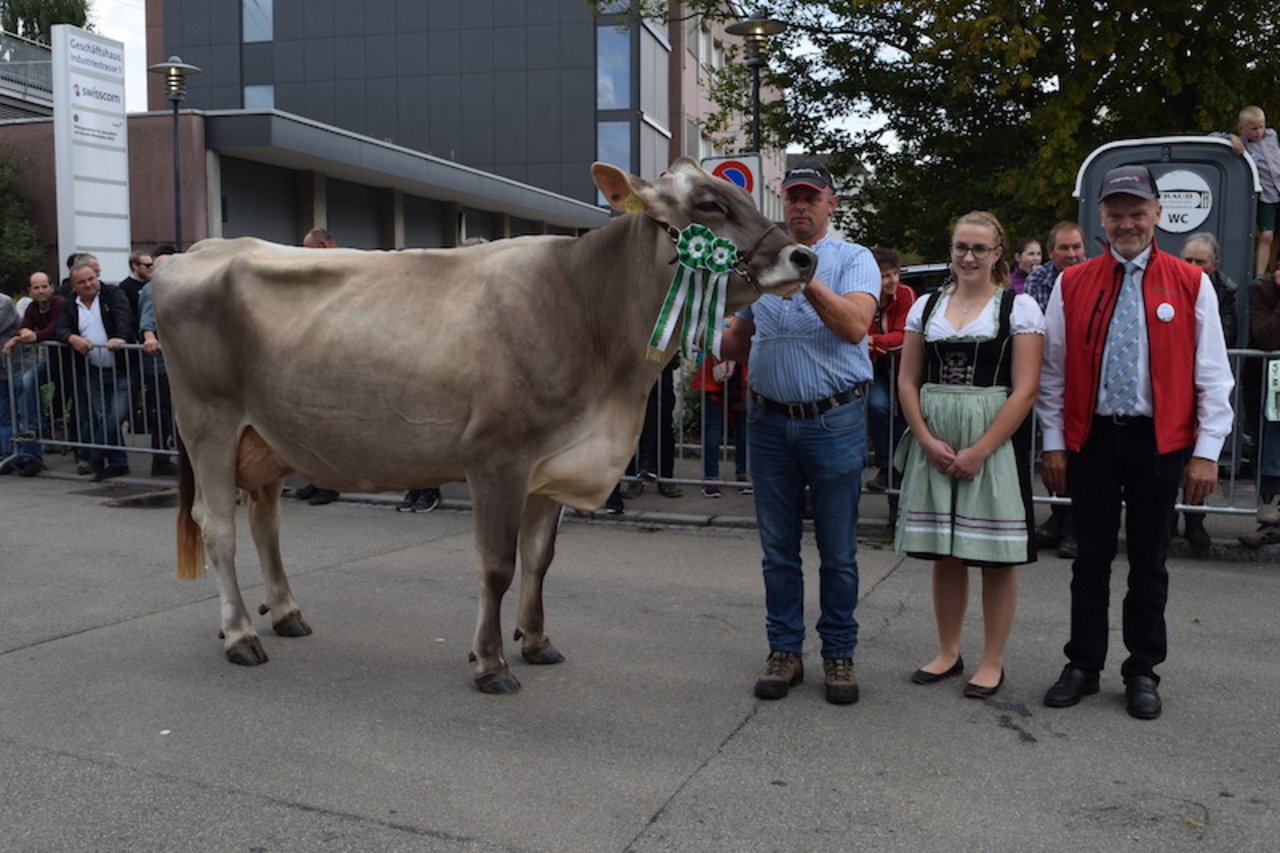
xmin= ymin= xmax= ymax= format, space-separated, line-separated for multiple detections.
xmin=591 ymin=158 xmax=818 ymax=296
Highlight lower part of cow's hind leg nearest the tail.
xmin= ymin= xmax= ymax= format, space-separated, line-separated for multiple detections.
xmin=192 ymin=481 xmax=268 ymax=666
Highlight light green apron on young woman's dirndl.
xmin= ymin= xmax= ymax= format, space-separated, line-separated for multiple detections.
xmin=893 ymin=383 xmax=1028 ymax=565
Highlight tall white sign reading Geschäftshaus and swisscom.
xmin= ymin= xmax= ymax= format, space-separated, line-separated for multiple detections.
xmin=52 ymin=24 xmax=132 ymax=284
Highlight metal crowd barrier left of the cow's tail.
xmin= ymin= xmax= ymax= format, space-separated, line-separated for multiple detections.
xmin=0 ymin=342 xmax=178 ymax=464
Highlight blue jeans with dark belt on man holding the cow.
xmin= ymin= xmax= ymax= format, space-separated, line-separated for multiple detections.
xmin=748 ymin=398 xmax=867 ymax=658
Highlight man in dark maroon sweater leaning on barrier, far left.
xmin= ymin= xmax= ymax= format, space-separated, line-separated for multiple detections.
xmin=3 ymin=273 xmax=67 ymax=476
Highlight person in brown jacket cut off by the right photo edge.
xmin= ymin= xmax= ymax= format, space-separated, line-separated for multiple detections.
xmin=1240 ymin=269 xmax=1280 ymax=548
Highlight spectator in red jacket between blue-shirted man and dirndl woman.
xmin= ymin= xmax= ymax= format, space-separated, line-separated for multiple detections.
xmin=865 ymin=246 xmax=915 ymax=512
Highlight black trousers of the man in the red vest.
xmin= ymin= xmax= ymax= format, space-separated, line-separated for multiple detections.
xmin=1064 ymin=416 xmax=1184 ymax=680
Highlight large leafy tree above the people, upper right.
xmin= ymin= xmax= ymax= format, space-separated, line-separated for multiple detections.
xmin=589 ymin=0 xmax=1280 ymax=259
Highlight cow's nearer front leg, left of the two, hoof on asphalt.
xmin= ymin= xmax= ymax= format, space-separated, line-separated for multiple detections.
xmin=471 ymin=479 xmax=525 ymax=693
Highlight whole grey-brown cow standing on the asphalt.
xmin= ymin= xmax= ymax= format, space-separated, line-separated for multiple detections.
xmin=155 ymin=159 xmax=817 ymax=693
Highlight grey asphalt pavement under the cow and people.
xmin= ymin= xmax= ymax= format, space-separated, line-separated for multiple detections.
xmin=0 ymin=464 xmax=1280 ymax=852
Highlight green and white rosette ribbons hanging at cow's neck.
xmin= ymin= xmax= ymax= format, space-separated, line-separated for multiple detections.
xmin=648 ymin=224 xmax=737 ymax=361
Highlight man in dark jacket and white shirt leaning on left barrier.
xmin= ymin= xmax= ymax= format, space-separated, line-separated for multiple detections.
xmin=58 ymin=259 xmax=136 ymax=480
